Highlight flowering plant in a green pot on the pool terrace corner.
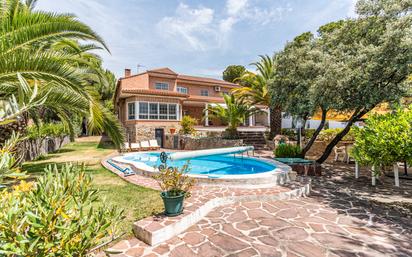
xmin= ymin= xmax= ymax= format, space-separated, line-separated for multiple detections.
xmin=155 ymin=163 xmax=195 ymax=216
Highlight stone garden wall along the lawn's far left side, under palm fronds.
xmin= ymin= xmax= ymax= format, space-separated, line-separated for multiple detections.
xmin=20 ymin=136 xmax=70 ymax=161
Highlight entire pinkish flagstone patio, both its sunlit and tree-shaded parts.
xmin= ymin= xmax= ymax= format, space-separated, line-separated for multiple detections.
xmin=100 ymin=153 xmax=412 ymax=257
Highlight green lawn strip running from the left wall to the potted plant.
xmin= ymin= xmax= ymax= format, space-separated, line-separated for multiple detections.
xmin=23 ymin=137 xmax=163 ymax=235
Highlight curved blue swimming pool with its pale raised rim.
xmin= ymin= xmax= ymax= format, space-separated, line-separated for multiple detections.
xmin=111 ymin=152 xmax=295 ymax=186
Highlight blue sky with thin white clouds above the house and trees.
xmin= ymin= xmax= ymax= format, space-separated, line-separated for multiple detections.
xmin=36 ymin=0 xmax=356 ymax=78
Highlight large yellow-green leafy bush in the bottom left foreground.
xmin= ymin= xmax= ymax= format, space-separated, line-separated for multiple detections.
xmin=0 ymin=164 xmax=123 ymax=257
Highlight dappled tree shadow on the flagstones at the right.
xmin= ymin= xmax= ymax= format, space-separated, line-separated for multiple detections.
xmin=311 ymin=163 xmax=412 ymax=234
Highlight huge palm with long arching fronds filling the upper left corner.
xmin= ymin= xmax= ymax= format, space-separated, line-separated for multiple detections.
xmin=0 ymin=0 xmax=124 ymax=146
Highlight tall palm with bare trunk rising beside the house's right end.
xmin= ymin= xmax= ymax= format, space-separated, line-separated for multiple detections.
xmin=233 ymin=55 xmax=282 ymax=138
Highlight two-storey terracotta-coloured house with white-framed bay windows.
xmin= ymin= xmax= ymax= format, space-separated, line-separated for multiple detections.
xmin=114 ymin=68 xmax=267 ymax=145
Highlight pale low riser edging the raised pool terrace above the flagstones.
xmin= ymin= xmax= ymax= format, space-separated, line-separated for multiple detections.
xmin=133 ymin=181 xmax=311 ymax=246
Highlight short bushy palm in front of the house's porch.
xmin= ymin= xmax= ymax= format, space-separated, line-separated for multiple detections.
xmin=206 ymin=94 xmax=257 ymax=138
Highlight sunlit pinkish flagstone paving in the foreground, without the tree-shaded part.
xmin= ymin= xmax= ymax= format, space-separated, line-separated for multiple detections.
xmin=105 ymin=195 xmax=412 ymax=257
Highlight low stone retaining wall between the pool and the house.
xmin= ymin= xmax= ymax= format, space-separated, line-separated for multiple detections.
xmin=165 ymin=135 xmax=243 ymax=150
